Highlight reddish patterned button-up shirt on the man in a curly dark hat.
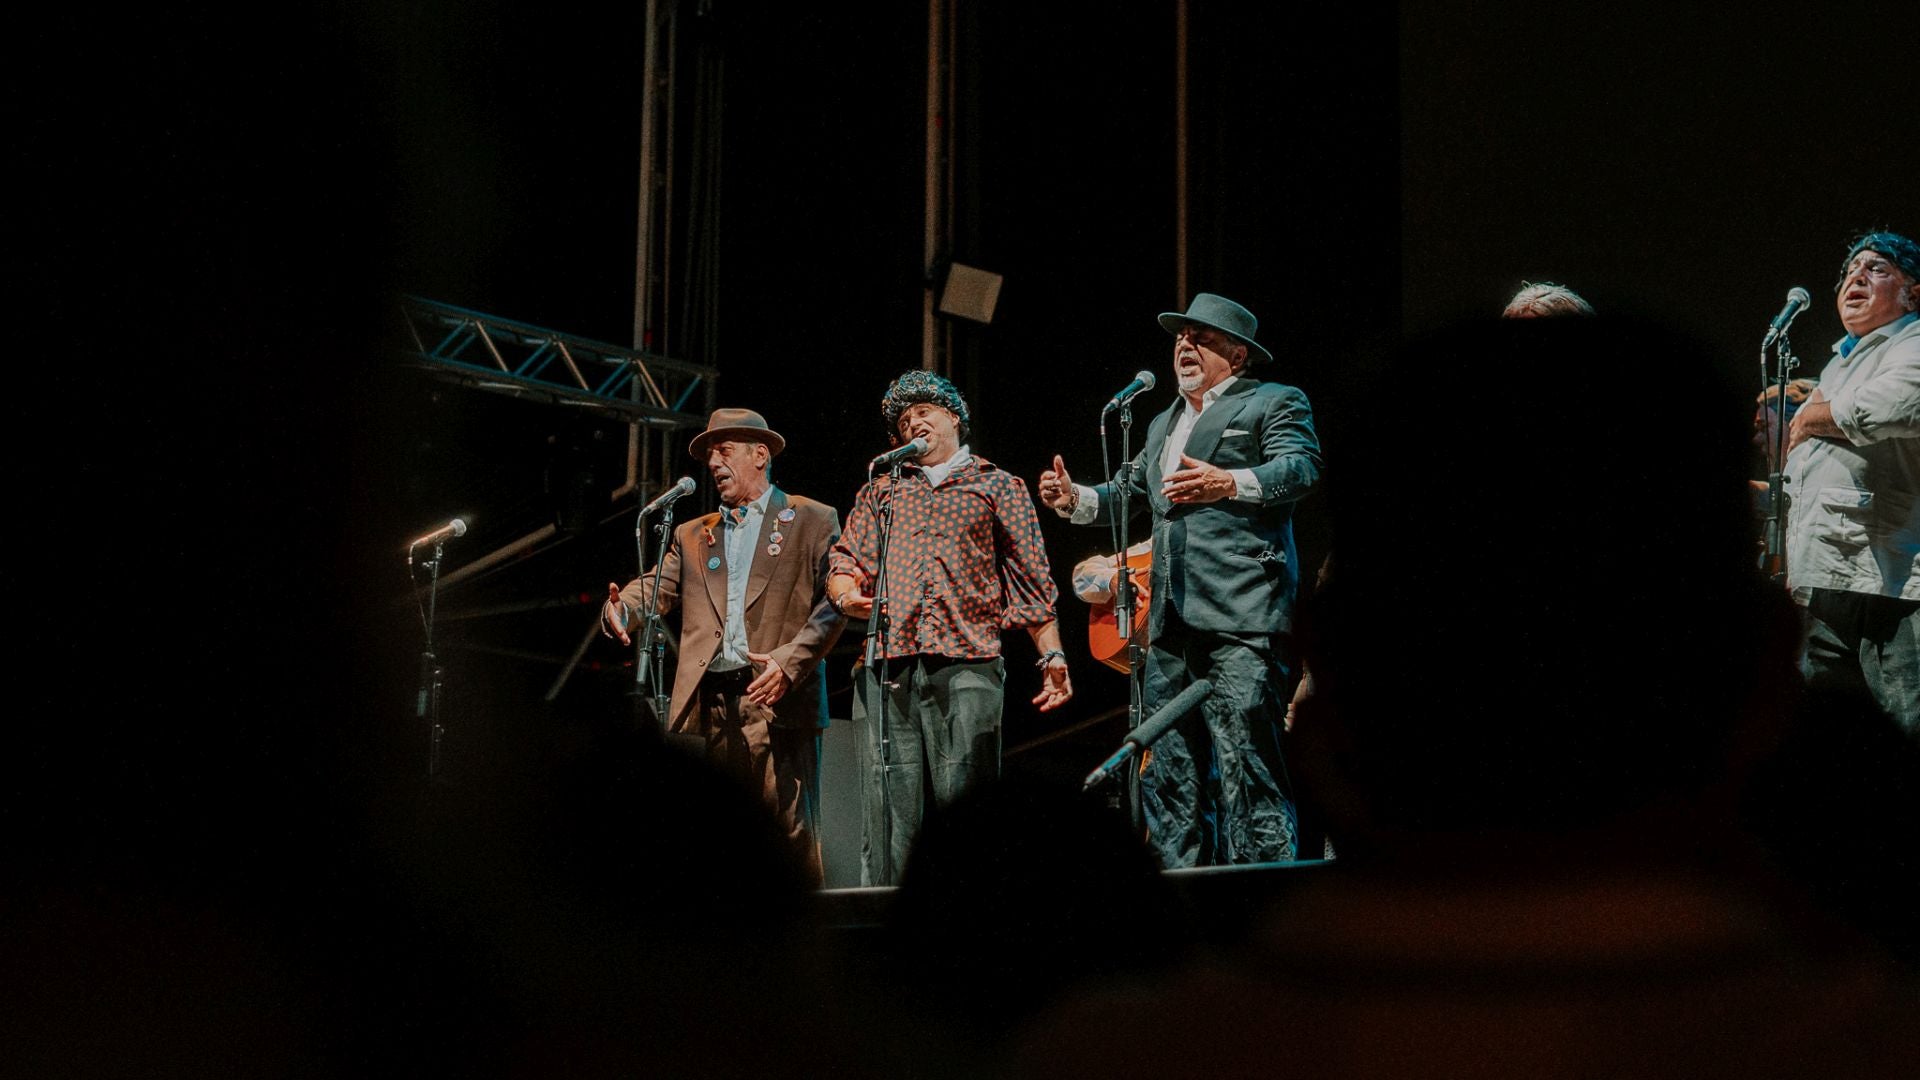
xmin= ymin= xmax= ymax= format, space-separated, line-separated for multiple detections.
xmin=828 ymin=457 xmax=1060 ymax=659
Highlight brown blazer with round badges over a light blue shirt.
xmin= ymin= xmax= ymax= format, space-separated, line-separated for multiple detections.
xmin=620 ymin=488 xmax=847 ymax=732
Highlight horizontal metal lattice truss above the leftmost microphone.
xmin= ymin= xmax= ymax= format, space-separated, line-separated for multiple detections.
xmin=401 ymin=296 xmax=720 ymax=430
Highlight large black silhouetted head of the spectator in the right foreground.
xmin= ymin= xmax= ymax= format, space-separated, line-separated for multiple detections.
xmin=1298 ymin=317 xmax=1793 ymax=844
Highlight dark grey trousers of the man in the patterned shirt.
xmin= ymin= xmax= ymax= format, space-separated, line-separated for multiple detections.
xmin=852 ymin=655 xmax=1006 ymax=886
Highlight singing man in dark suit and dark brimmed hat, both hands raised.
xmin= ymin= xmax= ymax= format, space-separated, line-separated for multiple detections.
xmin=1039 ymin=292 xmax=1321 ymax=869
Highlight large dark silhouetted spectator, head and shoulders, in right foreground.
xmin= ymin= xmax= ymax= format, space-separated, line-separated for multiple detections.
xmin=1018 ymin=317 xmax=1920 ymax=1078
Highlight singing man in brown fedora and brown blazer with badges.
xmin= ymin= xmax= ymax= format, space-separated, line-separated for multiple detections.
xmin=601 ymin=409 xmax=847 ymax=884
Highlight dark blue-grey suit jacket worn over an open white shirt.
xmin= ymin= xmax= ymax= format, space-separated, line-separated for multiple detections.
xmin=1094 ymin=377 xmax=1321 ymax=638
